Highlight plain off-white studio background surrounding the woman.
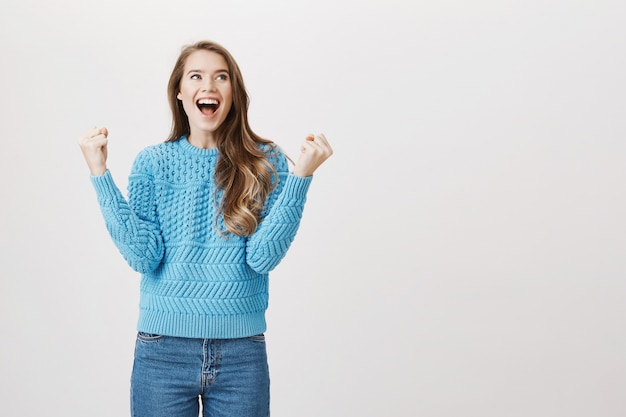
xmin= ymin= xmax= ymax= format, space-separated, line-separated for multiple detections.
xmin=0 ymin=0 xmax=626 ymax=417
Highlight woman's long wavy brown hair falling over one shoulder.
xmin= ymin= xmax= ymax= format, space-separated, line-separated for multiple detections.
xmin=167 ymin=41 xmax=278 ymax=236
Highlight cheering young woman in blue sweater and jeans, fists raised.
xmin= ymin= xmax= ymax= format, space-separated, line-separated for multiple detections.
xmin=79 ymin=41 xmax=332 ymax=417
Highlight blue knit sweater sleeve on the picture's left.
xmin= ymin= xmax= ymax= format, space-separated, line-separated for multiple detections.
xmin=91 ymin=150 xmax=164 ymax=273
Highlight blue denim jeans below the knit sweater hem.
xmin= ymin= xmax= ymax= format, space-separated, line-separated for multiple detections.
xmin=131 ymin=333 xmax=270 ymax=417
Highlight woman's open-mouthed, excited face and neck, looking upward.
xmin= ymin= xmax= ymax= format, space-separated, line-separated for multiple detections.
xmin=177 ymin=50 xmax=233 ymax=145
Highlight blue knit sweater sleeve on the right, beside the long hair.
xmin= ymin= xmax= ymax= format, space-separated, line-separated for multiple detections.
xmin=246 ymin=153 xmax=313 ymax=273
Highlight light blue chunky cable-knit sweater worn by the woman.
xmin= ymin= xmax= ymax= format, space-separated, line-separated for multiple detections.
xmin=91 ymin=137 xmax=312 ymax=338
